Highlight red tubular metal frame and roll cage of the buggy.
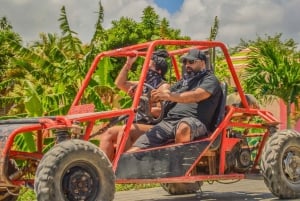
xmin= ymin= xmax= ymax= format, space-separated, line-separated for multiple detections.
xmin=0 ymin=40 xmax=278 ymax=188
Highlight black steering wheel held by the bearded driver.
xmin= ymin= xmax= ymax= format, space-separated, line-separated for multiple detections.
xmin=137 ymin=83 xmax=165 ymax=124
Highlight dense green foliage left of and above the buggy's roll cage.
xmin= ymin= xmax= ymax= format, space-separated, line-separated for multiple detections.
xmin=0 ymin=2 xmax=187 ymax=116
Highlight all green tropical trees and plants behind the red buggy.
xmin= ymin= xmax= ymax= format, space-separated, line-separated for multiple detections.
xmin=0 ymin=2 xmax=300 ymax=200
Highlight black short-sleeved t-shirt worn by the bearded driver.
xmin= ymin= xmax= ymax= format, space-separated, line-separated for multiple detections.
xmin=165 ymin=72 xmax=221 ymax=128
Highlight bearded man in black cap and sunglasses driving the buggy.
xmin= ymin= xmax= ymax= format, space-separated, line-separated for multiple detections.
xmin=129 ymin=49 xmax=222 ymax=152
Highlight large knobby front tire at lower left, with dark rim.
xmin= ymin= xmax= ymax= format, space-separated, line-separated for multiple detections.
xmin=34 ymin=140 xmax=115 ymax=201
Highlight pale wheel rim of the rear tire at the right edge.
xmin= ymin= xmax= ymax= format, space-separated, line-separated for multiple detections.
xmin=283 ymin=146 xmax=300 ymax=183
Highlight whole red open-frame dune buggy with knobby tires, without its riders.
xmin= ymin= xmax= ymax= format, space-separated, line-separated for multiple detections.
xmin=0 ymin=40 xmax=300 ymax=201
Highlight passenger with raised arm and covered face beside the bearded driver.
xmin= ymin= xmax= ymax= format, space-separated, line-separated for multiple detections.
xmin=100 ymin=50 xmax=168 ymax=161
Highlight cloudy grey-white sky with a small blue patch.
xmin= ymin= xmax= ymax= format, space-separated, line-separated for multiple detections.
xmin=0 ymin=0 xmax=300 ymax=47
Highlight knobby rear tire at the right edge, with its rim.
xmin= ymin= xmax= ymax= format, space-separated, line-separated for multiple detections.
xmin=260 ymin=130 xmax=300 ymax=199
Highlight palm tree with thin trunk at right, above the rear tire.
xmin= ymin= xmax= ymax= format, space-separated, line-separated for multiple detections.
xmin=243 ymin=34 xmax=300 ymax=128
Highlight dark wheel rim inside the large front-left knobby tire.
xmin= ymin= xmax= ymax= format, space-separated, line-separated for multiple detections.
xmin=61 ymin=163 xmax=100 ymax=201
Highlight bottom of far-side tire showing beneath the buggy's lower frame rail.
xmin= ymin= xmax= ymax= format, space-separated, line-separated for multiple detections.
xmin=160 ymin=182 xmax=202 ymax=195
